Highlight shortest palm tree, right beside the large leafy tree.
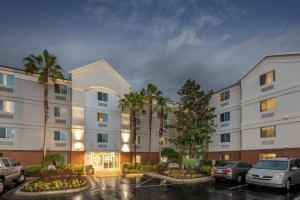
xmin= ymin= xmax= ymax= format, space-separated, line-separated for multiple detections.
xmin=154 ymin=96 xmax=171 ymax=139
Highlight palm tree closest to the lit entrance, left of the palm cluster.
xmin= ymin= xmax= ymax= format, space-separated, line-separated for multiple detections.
xmin=119 ymin=92 xmax=145 ymax=167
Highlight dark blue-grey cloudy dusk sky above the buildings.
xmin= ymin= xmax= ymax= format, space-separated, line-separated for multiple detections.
xmin=0 ymin=0 xmax=300 ymax=99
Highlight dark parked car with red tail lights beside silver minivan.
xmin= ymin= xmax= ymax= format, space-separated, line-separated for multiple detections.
xmin=212 ymin=161 xmax=252 ymax=183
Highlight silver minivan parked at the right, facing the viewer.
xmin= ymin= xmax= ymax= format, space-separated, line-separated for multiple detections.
xmin=246 ymin=158 xmax=300 ymax=190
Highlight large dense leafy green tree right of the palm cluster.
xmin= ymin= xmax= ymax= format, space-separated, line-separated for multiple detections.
xmin=172 ymin=79 xmax=215 ymax=158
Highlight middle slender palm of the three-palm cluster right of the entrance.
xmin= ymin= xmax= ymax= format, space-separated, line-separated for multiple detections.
xmin=141 ymin=83 xmax=162 ymax=152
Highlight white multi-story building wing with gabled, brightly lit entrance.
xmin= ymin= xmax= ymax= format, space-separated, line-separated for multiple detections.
xmin=0 ymin=60 xmax=175 ymax=175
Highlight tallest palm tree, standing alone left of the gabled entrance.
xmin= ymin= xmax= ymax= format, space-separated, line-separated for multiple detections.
xmin=23 ymin=49 xmax=64 ymax=166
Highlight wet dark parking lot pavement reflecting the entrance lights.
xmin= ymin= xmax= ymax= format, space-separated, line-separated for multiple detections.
xmin=2 ymin=176 xmax=300 ymax=200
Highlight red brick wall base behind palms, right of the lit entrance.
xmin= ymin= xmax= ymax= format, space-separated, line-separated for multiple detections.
xmin=121 ymin=152 xmax=159 ymax=164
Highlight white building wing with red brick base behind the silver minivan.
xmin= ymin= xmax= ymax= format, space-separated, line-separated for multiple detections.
xmin=208 ymin=53 xmax=300 ymax=163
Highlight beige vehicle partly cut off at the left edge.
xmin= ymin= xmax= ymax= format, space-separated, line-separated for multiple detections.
xmin=0 ymin=157 xmax=26 ymax=193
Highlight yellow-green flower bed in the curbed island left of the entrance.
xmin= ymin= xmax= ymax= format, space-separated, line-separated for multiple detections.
xmin=22 ymin=176 xmax=88 ymax=192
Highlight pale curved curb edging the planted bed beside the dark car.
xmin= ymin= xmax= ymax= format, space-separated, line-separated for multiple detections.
xmin=145 ymin=172 xmax=213 ymax=184
